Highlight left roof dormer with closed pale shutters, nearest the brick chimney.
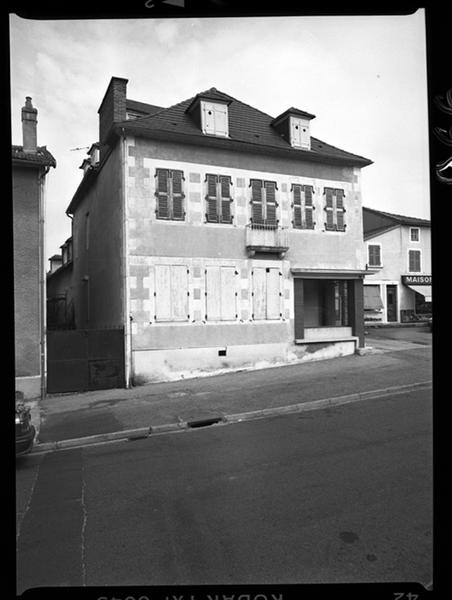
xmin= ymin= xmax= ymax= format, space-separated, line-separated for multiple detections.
xmin=186 ymin=88 xmax=231 ymax=137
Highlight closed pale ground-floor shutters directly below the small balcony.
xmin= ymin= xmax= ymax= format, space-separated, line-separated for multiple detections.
xmin=252 ymin=267 xmax=282 ymax=321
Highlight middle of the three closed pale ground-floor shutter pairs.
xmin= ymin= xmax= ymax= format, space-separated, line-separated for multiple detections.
xmin=205 ymin=266 xmax=238 ymax=321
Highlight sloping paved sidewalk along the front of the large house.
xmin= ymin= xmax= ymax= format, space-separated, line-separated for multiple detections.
xmin=35 ymin=339 xmax=432 ymax=451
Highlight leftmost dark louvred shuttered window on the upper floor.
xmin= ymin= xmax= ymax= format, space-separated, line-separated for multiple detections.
xmin=155 ymin=169 xmax=185 ymax=221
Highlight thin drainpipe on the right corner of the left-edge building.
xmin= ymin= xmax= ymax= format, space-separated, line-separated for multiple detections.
xmin=38 ymin=167 xmax=50 ymax=405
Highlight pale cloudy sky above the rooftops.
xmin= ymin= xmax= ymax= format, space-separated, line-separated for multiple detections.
xmin=10 ymin=9 xmax=430 ymax=258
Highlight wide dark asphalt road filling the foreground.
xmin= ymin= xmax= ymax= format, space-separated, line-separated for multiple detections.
xmin=17 ymin=391 xmax=432 ymax=593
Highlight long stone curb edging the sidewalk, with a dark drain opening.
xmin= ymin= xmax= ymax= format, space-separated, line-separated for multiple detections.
xmin=31 ymin=380 xmax=432 ymax=454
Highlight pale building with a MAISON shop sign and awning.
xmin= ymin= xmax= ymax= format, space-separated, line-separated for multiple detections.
xmin=363 ymin=207 xmax=432 ymax=323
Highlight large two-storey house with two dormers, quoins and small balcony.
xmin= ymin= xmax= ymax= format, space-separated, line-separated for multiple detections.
xmin=67 ymin=77 xmax=371 ymax=383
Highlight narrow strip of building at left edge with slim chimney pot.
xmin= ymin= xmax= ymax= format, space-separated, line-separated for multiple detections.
xmin=12 ymin=97 xmax=56 ymax=398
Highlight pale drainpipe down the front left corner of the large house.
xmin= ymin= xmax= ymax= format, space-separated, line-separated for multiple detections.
xmin=121 ymin=128 xmax=133 ymax=388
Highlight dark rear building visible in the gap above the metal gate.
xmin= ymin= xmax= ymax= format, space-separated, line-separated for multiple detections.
xmin=47 ymin=237 xmax=75 ymax=330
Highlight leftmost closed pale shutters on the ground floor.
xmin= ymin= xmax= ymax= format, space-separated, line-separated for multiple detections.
xmin=154 ymin=265 xmax=190 ymax=321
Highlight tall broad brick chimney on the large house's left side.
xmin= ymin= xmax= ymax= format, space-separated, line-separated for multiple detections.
xmin=97 ymin=77 xmax=128 ymax=160
